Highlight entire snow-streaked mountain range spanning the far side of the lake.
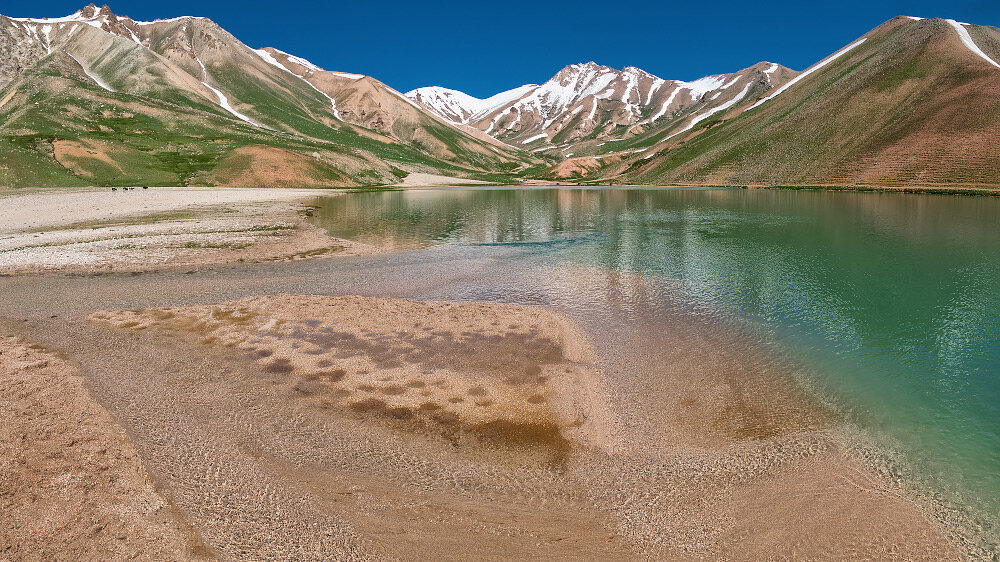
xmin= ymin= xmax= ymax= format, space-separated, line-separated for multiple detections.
xmin=0 ymin=4 xmax=1000 ymax=187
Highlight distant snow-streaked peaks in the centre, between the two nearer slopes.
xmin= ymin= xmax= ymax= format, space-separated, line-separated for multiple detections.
xmin=406 ymin=62 xmax=796 ymax=151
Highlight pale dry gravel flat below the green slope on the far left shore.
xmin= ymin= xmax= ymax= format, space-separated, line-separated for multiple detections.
xmin=0 ymin=187 xmax=380 ymax=274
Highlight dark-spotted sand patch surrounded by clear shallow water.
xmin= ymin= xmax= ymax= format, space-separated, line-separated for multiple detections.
xmin=91 ymin=295 xmax=606 ymax=465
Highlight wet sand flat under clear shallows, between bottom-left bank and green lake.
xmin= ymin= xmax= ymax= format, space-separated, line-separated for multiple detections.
xmin=0 ymin=191 xmax=961 ymax=560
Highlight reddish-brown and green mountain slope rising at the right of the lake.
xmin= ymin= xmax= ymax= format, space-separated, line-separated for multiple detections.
xmin=608 ymin=17 xmax=1000 ymax=186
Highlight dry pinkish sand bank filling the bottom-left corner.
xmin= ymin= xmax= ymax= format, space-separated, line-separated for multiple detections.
xmin=0 ymin=337 xmax=214 ymax=560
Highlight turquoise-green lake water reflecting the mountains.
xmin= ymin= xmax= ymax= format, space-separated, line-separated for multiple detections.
xmin=308 ymin=188 xmax=1000 ymax=526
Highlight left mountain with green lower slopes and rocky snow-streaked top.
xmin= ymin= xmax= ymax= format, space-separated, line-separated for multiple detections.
xmin=0 ymin=4 xmax=539 ymax=186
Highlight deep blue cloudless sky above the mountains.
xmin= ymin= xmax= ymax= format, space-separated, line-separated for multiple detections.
xmin=7 ymin=0 xmax=1000 ymax=97
